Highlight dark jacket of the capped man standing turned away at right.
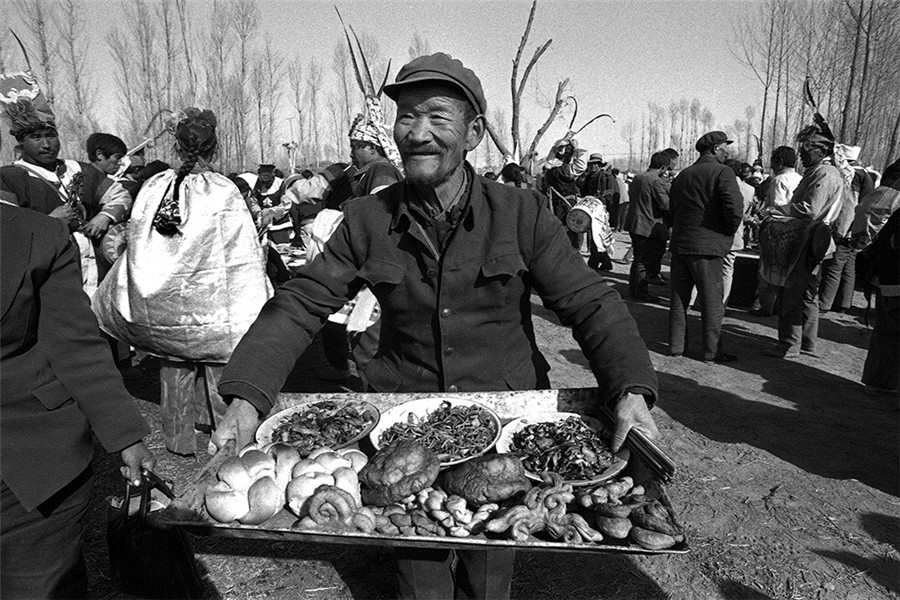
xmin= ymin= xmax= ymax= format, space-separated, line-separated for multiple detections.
xmin=669 ymin=154 xmax=744 ymax=257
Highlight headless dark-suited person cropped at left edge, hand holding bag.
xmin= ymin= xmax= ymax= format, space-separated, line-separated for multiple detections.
xmin=0 ymin=203 xmax=155 ymax=598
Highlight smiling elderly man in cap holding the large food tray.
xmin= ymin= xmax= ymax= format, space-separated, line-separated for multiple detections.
xmin=214 ymin=53 xmax=658 ymax=598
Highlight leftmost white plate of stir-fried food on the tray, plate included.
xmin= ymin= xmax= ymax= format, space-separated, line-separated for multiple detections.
xmin=256 ymin=400 xmax=380 ymax=456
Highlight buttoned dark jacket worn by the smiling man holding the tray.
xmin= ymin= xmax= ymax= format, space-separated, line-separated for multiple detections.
xmin=219 ymin=167 xmax=657 ymax=413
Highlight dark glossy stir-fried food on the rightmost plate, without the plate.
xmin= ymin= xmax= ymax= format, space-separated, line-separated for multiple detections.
xmin=510 ymin=417 xmax=615 ymax=481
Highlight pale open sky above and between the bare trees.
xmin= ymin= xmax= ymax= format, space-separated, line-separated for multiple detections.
xmin=8 ymin=0 xmax=759 ymax=164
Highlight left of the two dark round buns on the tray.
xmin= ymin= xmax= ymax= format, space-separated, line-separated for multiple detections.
xmin=359 ymin=440 xmax=441 ymax=506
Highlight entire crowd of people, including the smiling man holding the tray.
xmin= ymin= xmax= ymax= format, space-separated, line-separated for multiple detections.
xmin=0 ymin=47 xmax=900 ymax=598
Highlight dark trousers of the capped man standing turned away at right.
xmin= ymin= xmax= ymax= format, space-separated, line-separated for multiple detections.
xmin=669 ymin=254 xmax=725 ymax=360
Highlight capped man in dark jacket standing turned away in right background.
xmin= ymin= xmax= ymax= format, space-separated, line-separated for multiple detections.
xmin=669 ymin=131 xmax=744 ymax=363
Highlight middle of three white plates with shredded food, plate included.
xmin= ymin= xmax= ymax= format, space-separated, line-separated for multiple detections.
xmin=369 ymin=397 xmax=501 ymax=469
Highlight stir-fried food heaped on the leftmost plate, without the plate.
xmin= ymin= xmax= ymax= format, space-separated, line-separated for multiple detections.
xmin=272 ymin=400 xmax=375 ymax=456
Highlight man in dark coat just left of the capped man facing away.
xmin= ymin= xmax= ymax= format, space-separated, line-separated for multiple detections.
xmin=625 ymin=151 xmax=670 ymax=302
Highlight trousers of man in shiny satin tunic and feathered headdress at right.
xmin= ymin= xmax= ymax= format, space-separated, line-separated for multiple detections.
xmin=778 ymin=258 xmax=819 ymax=352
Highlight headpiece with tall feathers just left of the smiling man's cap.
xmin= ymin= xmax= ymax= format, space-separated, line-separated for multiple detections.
xmin=334 ymin=6 xmax=403 ymax=173
